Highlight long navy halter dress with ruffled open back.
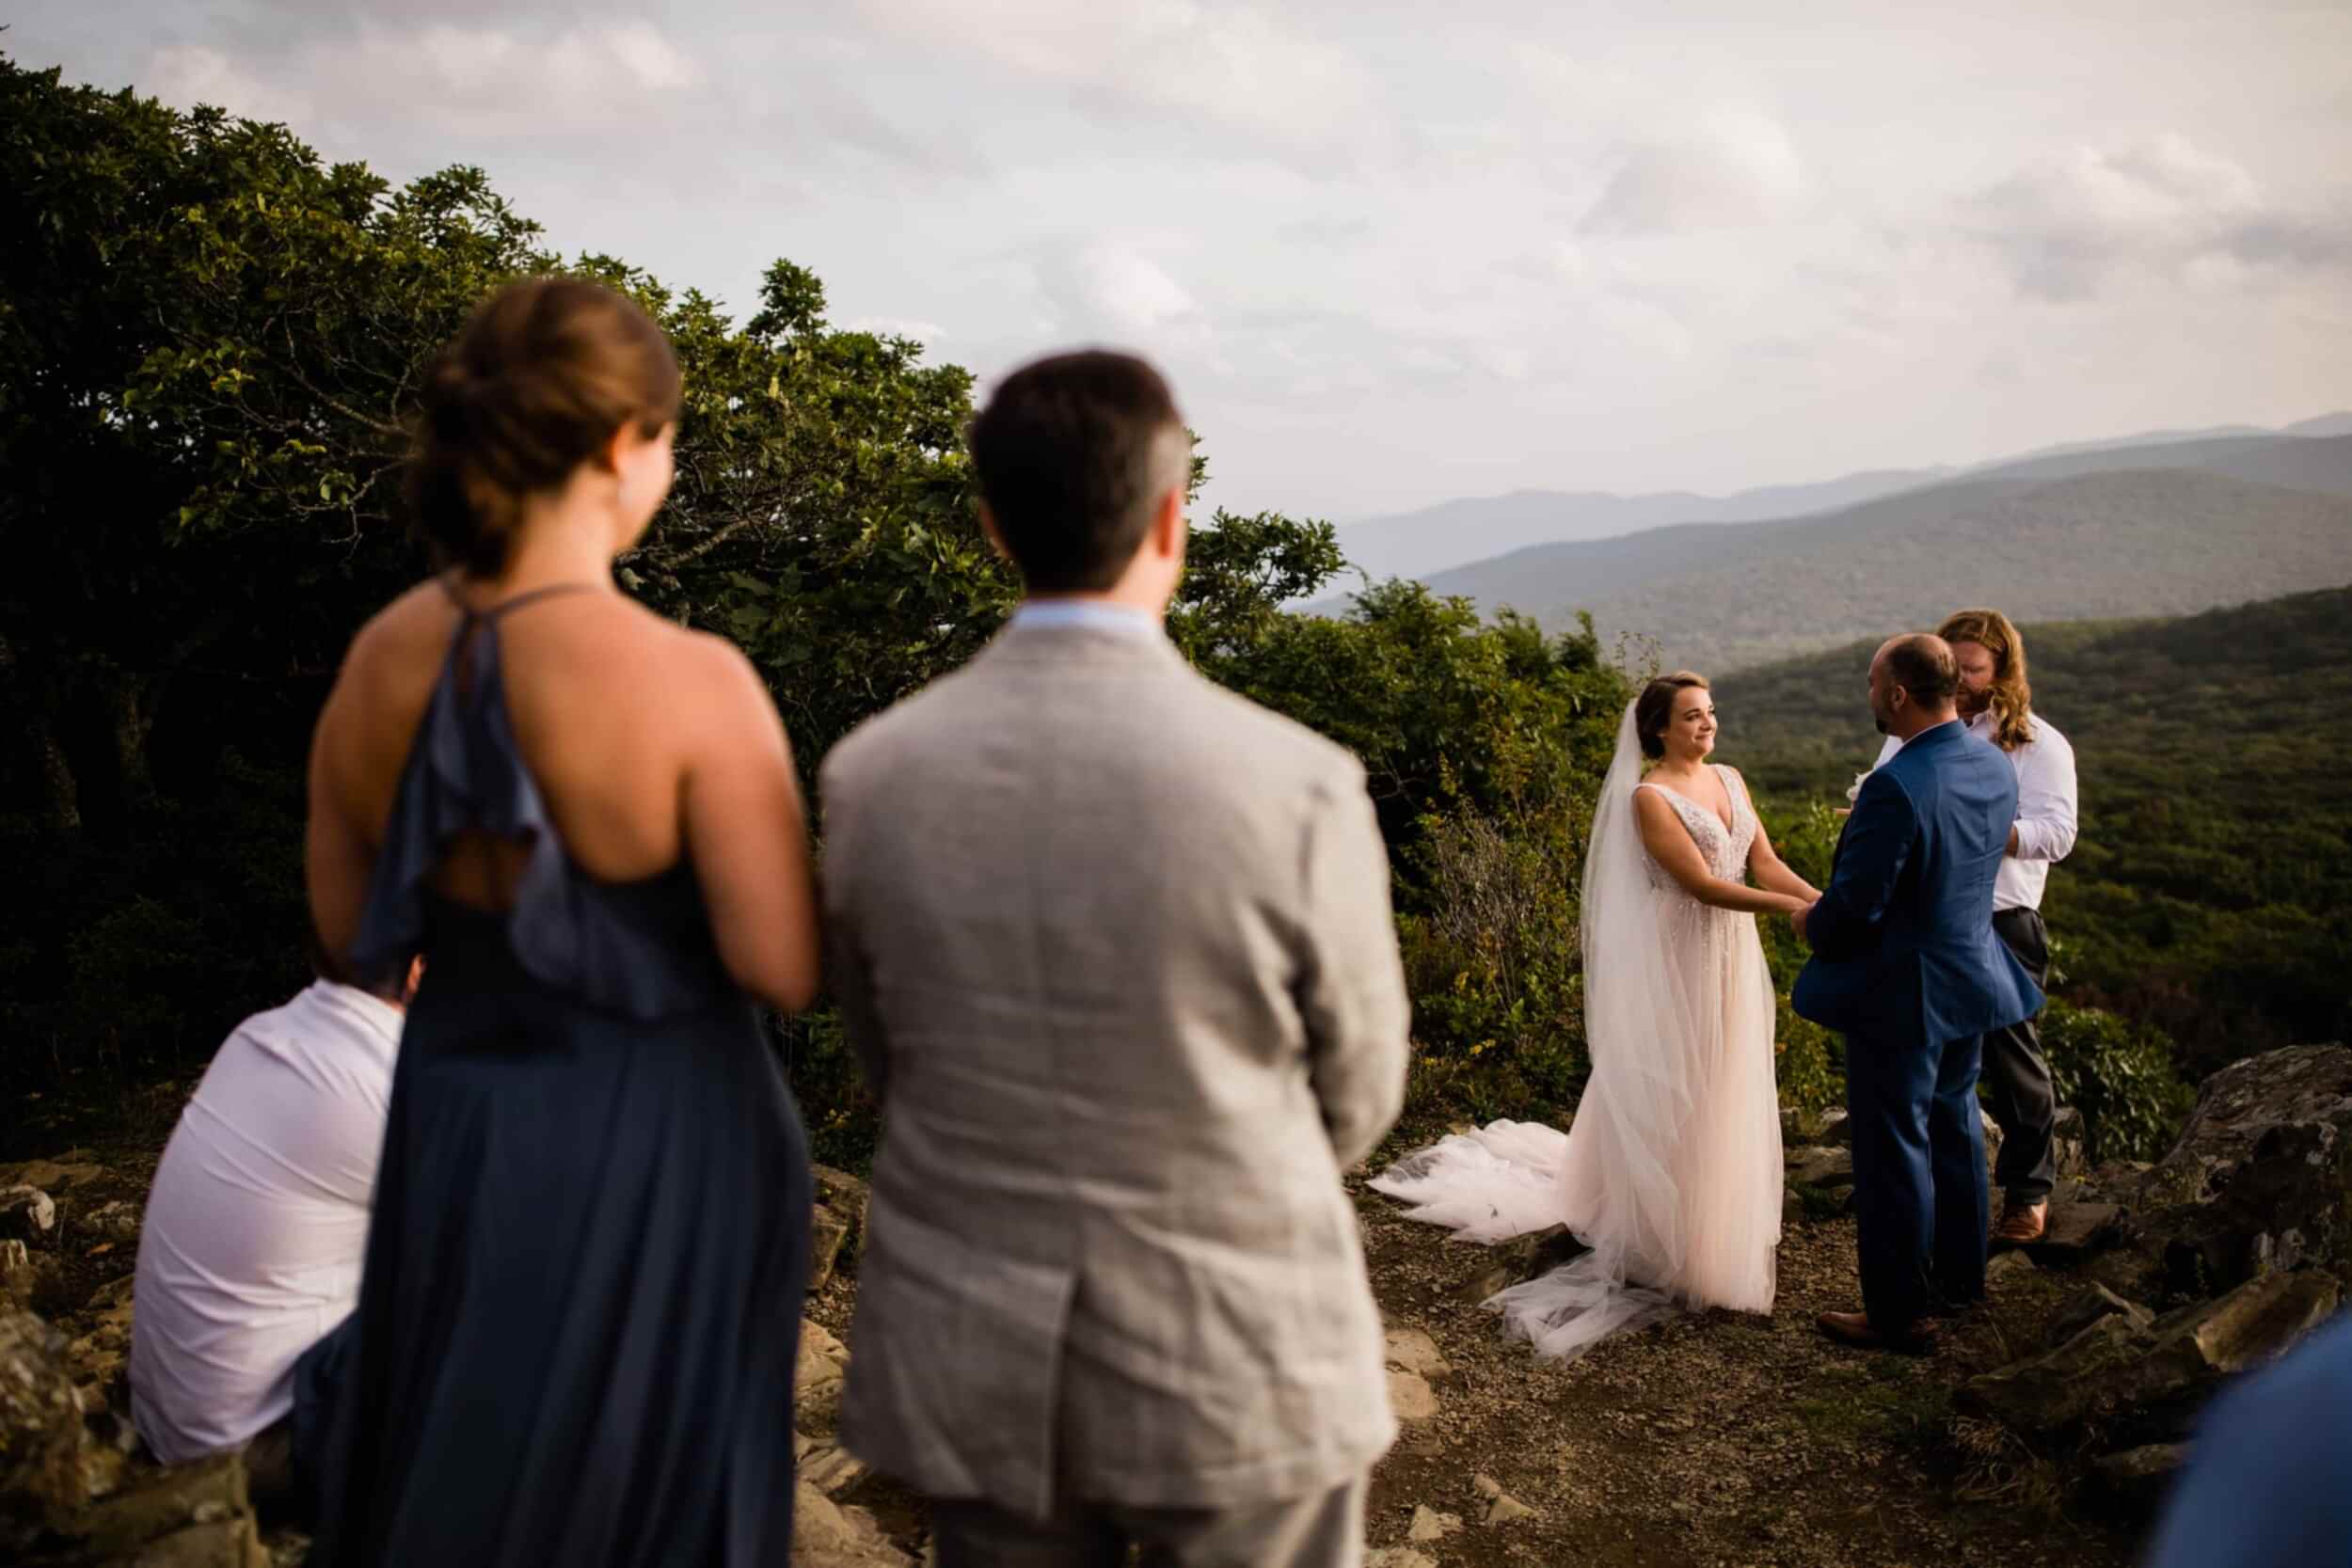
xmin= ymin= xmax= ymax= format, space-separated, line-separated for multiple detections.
xmin=310 ymin=594 xmax=809 ymax=1568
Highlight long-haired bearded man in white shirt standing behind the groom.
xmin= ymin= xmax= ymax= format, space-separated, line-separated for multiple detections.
xmin=1880 ymin=609 xmax=2082 ymax=1246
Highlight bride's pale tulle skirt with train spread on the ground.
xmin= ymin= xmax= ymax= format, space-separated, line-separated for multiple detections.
xmin=1372 ymin=895 xmax=1781 ymax=1356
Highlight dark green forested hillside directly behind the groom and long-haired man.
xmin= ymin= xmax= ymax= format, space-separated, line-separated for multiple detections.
xmin=1717 ymin=588 xmax=2352 ymax=1077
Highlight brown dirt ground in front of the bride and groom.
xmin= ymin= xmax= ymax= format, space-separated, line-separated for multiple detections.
xmin=1353 ymin=1182 xmax=2134 ymax=1568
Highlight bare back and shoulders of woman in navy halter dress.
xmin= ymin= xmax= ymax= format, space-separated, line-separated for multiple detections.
xmin=313 ymin=580 xmax=814 ymax=999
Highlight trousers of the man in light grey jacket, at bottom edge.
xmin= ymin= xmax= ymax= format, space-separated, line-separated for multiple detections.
xmin=931 ymin=1477 xmax=1369 ymax=1568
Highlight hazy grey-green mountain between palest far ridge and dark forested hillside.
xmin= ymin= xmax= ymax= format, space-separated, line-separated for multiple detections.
xmin=1317 ymin=414 xmax=2352 ymax=673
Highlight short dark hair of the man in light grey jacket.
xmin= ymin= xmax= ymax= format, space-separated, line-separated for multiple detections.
xmin=972 ymin=350 xmax=1190 ymax=593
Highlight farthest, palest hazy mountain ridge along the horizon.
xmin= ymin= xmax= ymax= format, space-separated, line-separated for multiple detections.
xmin=1339 ymin=414 xmax=2352 ymax=580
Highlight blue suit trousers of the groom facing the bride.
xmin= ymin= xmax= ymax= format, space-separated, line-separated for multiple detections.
xmin=1847 ymin=1035 xmax=1988 ymax=1338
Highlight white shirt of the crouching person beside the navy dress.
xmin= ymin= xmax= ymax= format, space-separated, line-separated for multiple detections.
xmin=132 ymin=980 xmax=403 ymax=1465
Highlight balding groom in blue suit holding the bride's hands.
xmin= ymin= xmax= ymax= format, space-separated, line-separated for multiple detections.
xmin=1790 ymin=635 xmax=2042 ymax=1352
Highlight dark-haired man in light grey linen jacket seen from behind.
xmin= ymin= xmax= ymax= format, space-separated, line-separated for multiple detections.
xmin=823 ymin=353 xmax=1406 ymax=1568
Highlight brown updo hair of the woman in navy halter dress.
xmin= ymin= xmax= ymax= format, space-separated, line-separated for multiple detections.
xmin=407 ymin=277 xmax=680 ymax=576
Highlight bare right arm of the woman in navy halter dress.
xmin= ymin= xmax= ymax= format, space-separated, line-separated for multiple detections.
xmin=682 ymin=637 xmax=821 ymax=1013
